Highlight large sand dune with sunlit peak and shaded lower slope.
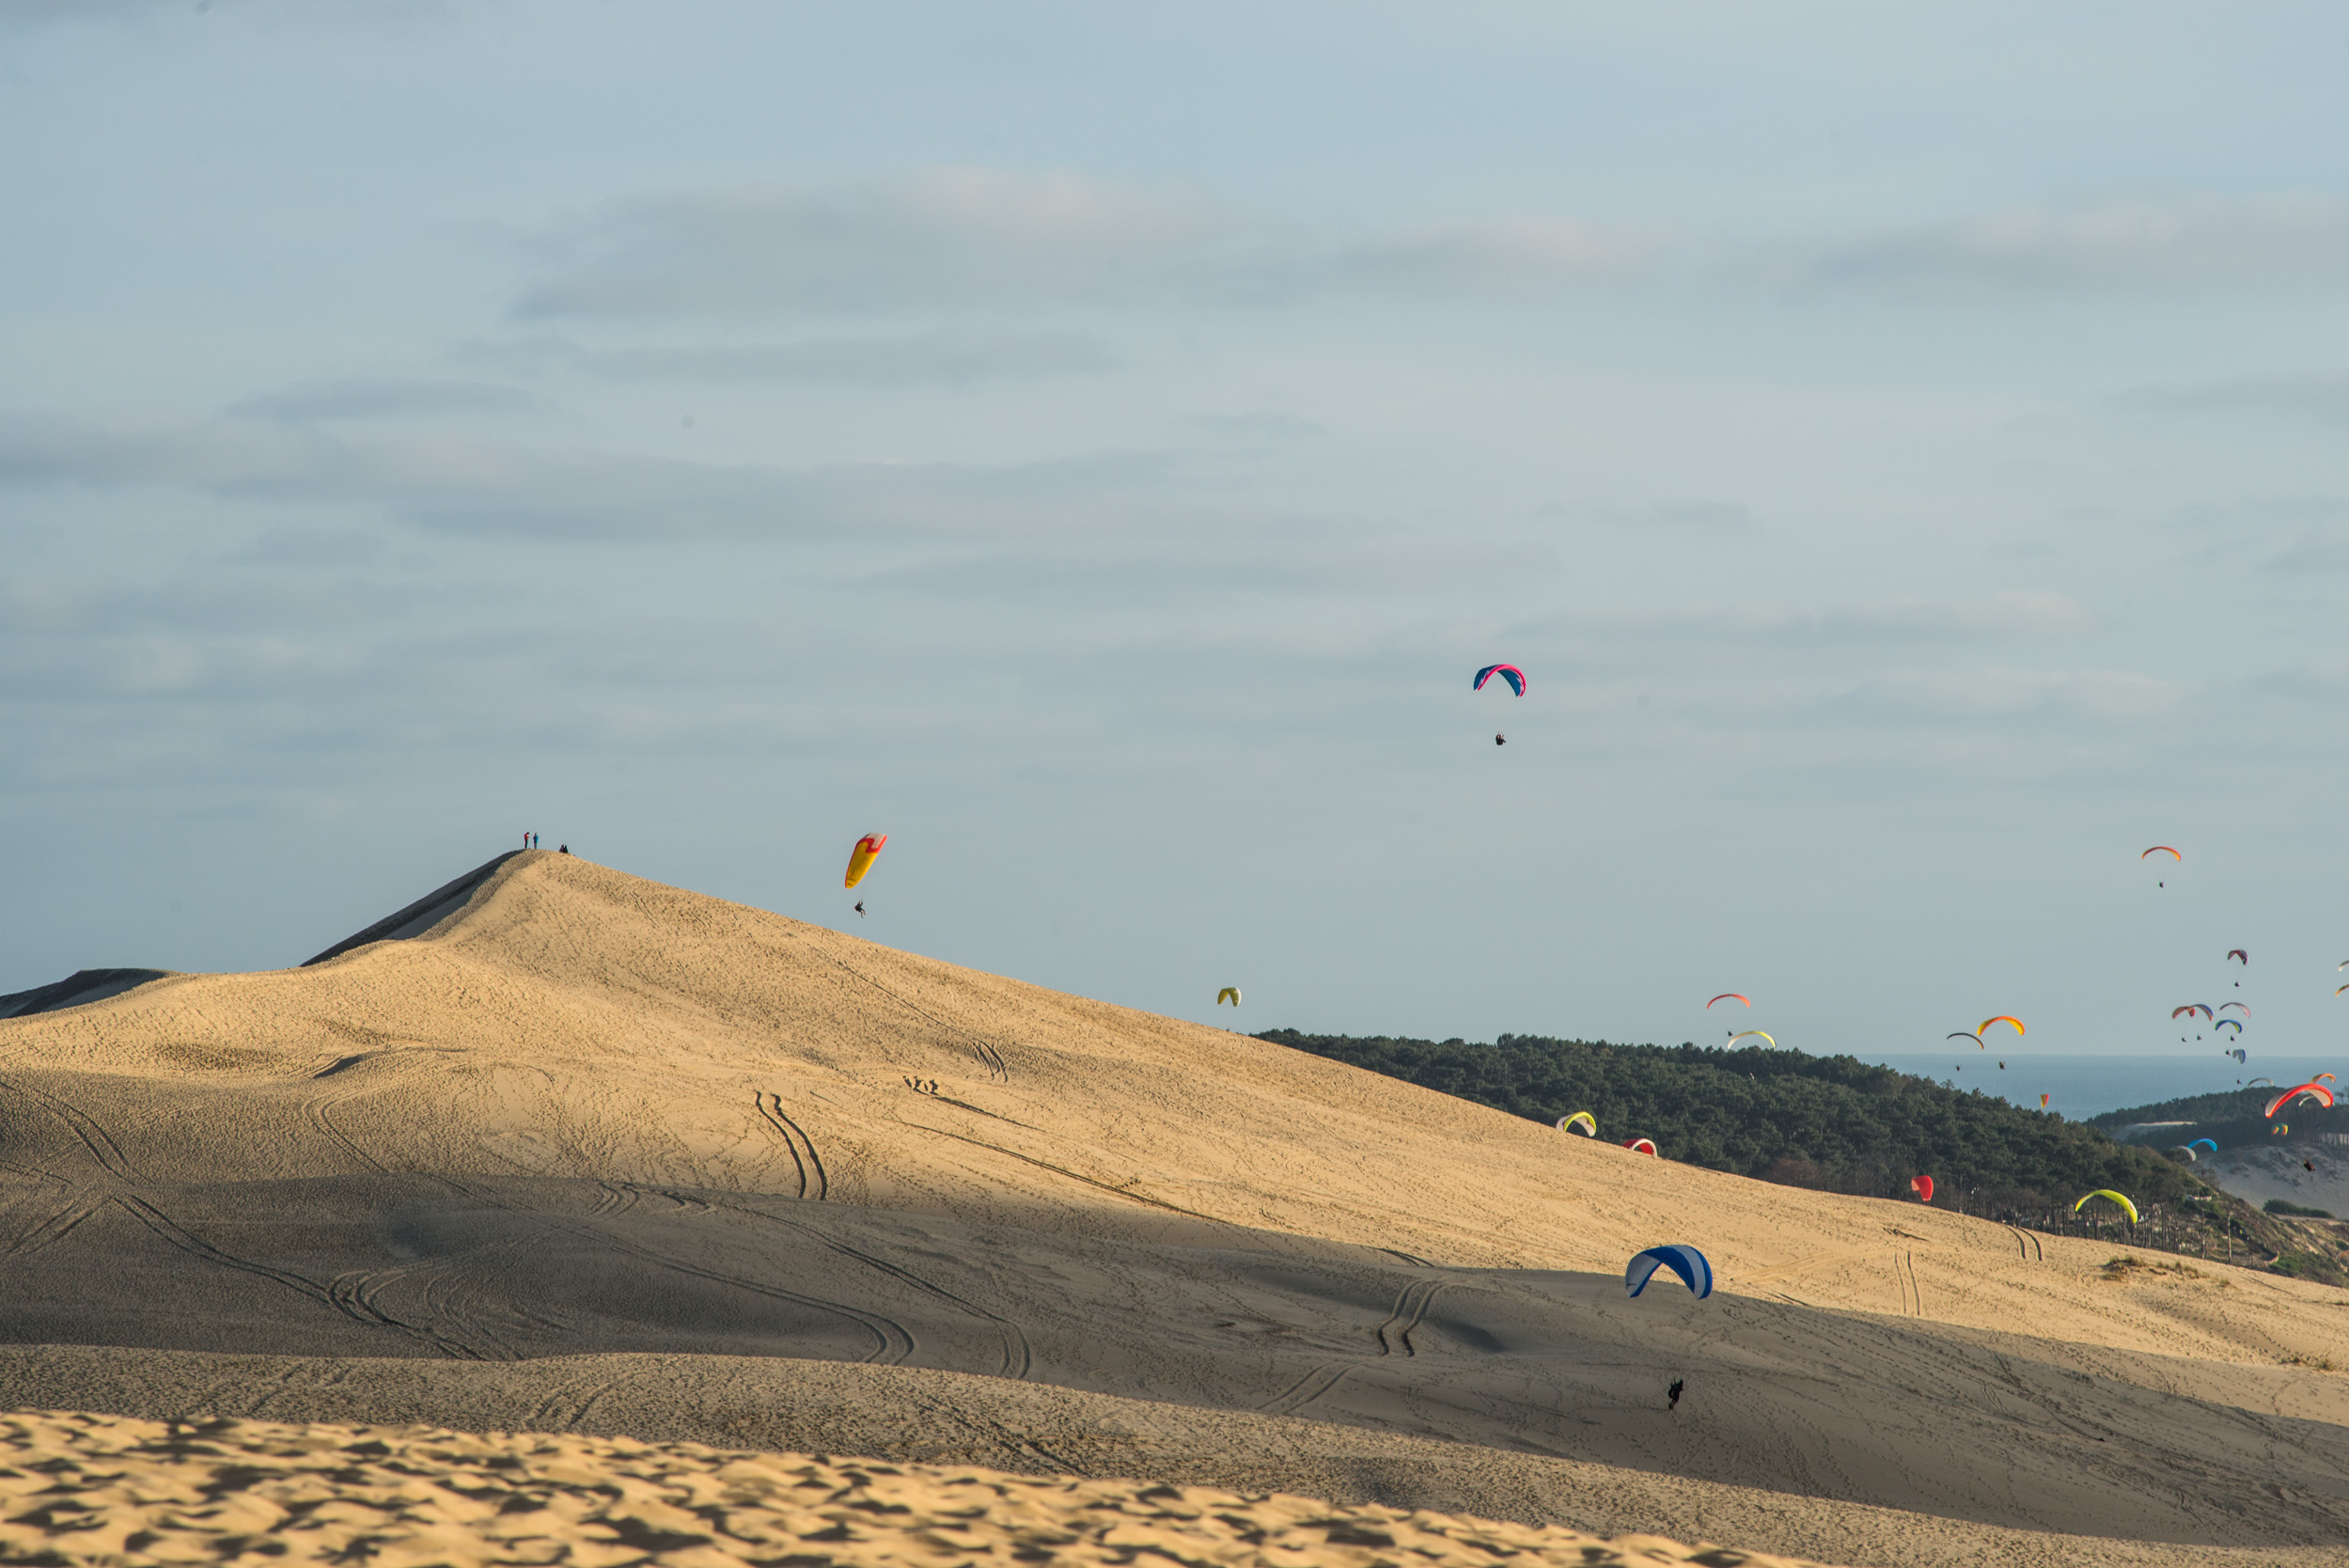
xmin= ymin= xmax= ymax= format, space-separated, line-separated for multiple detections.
xmin=0 ymin=854 xmax=2349 ymax=1563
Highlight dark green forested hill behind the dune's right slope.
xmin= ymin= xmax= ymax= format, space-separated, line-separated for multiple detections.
xmin=1257 ymin=1029 xmax=2199 ymax=1213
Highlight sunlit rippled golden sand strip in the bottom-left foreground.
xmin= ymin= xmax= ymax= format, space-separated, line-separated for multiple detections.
xmin=0 ymin=1410 xmax=1832 ymax=1568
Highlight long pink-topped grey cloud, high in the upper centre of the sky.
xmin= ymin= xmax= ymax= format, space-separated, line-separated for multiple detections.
xmin=514 ymin=169 xmax=1675 ymax=318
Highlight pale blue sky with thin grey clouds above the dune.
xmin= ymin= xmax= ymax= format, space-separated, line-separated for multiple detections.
xmin=0 ymin=0 xmax=2349 ymax=1053
